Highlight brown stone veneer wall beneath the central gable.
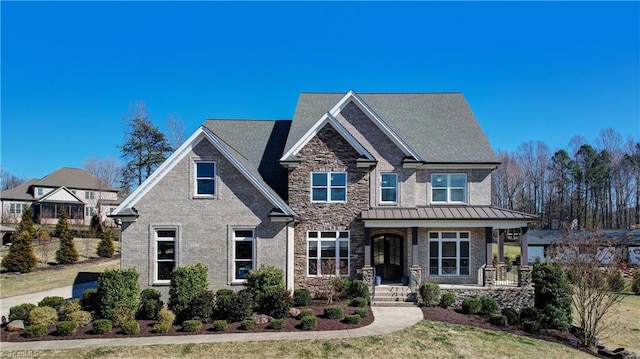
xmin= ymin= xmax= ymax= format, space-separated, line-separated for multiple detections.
xmin=288 ymin=125 xmax=370 ymax=292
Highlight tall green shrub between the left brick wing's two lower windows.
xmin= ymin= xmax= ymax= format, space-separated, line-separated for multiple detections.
xmin=169 ymin=263 xmax=207 ymax=321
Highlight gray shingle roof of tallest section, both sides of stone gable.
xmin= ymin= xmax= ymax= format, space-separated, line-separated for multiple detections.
xmin=284 ymin=93 xmax=498 ymax=163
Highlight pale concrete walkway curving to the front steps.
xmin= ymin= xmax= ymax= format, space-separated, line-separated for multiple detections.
xmin=0 ymin=307 xmax=423 ymax=352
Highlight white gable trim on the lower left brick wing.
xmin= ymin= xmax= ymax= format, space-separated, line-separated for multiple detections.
xmin=111 ymin=126 xmax=295 ymax=216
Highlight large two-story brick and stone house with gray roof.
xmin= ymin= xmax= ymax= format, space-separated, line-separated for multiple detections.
xmin=113 ymin=91 xmax=538 ymax=300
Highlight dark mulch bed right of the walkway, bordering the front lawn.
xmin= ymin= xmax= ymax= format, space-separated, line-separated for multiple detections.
xmin=422 ymin=307 xmax=601 ymax=357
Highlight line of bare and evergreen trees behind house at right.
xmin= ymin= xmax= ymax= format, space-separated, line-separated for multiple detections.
xmin=492 ymin=128 xmax=640 ymax=229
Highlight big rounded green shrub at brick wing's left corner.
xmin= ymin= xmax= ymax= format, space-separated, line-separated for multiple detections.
xmin=97 ymin=268 xmax=140 ymax=318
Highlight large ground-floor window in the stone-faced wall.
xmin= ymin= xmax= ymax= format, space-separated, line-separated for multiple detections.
xmin=307 ymin=231 xmax=349 ymax=276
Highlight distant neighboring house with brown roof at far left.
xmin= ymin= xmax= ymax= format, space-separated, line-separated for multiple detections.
xmin=0 ymin=167 xmax=120 ymax=225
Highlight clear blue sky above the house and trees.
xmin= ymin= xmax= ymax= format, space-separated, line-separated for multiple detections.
xmin=0 ymin=1 xmax=640 ymax=183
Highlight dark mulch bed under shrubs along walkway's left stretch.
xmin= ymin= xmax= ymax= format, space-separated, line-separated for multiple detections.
xmin=0 ymin=301 xmax=373 ymax=342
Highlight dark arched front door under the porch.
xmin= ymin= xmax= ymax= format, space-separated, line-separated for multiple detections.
xmin=371 ymin=234 xmax=404 ymax=281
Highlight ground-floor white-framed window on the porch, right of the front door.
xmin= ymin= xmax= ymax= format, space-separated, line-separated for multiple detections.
xmin=429 ymin=232 xmax=469 ymax=276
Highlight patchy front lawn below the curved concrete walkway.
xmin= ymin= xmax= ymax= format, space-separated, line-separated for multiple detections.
xmin=6 ymin=320 xmax=592 ymax=359
